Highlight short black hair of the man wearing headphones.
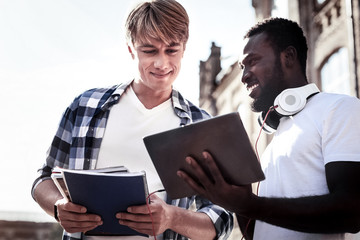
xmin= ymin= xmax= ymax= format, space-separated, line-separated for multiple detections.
xmin=244 ymin=17 xmax=308 ymax=77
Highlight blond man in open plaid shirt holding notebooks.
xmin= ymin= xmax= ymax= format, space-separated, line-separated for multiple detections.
xmin=32 ymin=0 xmax=233 ymax=240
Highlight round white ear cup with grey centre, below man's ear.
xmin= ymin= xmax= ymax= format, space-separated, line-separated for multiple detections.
xmin=274 ymin=89 xmax=306 ymax=116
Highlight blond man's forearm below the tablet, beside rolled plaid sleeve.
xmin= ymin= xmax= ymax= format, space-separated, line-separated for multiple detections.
xmin=170 ymin=206 xmax=216 ymax=240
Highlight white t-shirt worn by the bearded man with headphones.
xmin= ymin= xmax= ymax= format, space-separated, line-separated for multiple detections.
xmin=254 ymin=93 xmax=360 ymax=240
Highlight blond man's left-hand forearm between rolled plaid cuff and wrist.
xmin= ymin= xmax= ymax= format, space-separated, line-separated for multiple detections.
xmin=34 ymin=179 xmax=63 ymax=216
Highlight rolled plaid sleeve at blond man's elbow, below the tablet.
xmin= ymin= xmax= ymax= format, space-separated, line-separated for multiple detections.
xmin=195 ymin=196 xmax=234 ymax=239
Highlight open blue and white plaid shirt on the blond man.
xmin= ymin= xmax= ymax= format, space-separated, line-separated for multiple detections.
xmin=32 ymin=82 xmax=233 ymax=240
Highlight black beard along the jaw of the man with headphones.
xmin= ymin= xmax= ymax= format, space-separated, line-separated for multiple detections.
xmin=251 ymin=58 xmax=284 ymax=112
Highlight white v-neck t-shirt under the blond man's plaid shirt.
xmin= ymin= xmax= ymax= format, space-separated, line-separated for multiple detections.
xmin=86 ymin=87 xmax=180 ymax=240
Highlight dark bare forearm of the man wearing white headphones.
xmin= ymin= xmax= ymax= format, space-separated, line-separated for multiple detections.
xmin=243 ymin=194 xmax=360 ymax=233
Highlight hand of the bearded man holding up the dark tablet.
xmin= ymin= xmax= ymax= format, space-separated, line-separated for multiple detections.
xmin=178 ymin=152 xmax=254 ymax=214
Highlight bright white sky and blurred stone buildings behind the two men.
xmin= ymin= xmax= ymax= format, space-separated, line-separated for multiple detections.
xmin=0 ymin=0 xmax=360 ymax=240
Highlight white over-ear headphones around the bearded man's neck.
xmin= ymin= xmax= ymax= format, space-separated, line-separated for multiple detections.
xmin=258 ymin=83 xmax=320 ymax=134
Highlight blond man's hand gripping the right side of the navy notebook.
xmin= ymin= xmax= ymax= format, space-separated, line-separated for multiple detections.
xmin=116 ymin=194 xmax=171 ymax=236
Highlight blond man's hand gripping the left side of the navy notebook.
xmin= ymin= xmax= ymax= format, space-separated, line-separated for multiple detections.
xmin=55 ymin=199 xmax=102 ymax=233
